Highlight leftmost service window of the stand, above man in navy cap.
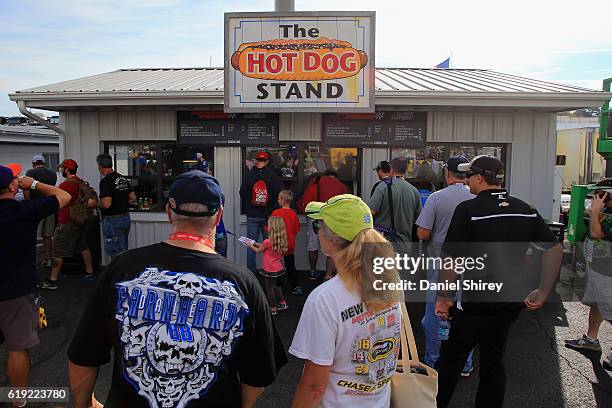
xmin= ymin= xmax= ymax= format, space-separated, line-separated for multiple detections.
xmin=105 ymin=142 xmax=214 ymax=211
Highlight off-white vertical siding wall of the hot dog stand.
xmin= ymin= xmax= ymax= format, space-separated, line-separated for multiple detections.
xmin=60 ymin=111 xmax=556 ymax=268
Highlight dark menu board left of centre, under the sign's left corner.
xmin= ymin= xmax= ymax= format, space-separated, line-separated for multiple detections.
xmin=177 ymin=111 xmax=278 ymax=146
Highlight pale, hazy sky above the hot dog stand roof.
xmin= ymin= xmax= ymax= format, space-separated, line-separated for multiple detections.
xmin=0 ymin=0 xmax=612 ymax=115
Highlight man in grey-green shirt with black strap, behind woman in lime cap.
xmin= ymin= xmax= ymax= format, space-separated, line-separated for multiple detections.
xmin=368 ymin=157 xmax=421 ymax=243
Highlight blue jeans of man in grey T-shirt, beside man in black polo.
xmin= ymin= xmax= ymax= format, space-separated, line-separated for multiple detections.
xmin=421 ymin=270 xmax=474 ymax=372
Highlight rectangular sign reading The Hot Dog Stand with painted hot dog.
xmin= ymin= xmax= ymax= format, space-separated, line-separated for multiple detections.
xmin=224 ymin=12 xmax=375 ymax=112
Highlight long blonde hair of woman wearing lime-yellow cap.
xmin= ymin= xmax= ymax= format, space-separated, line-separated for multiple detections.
xmin=321 ymin=224 xmax=404 ymax=312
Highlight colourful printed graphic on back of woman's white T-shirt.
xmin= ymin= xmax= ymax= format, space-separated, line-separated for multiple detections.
xmin=336 ymin=303 xmax=401 ymax=395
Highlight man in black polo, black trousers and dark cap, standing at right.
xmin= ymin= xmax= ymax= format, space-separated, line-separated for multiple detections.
xmin=436 ymin=156 xmax=562 ymax=408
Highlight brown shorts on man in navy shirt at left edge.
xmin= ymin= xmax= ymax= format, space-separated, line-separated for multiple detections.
xmin=0 ymin=293 xmax=39 ymax=351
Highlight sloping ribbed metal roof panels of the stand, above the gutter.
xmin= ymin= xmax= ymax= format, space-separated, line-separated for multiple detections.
xmin=16 ymin=68 xmax=601 ymax=94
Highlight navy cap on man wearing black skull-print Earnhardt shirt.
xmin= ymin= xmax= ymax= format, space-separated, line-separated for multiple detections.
xmin=168 ymin=170 xmax=223 ymax=217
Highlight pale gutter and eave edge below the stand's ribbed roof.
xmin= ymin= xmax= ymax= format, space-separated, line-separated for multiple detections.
xmin=9 ymin=91 xmax=612 ymax=112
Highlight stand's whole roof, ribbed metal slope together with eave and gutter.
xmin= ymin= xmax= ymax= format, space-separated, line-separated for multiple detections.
xmin=9 ymin=68 xmax=612 ymax=112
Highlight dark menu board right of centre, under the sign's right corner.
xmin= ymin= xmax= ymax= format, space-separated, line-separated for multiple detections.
xmin=323 ymin=111 xmax=427 ymax=148
